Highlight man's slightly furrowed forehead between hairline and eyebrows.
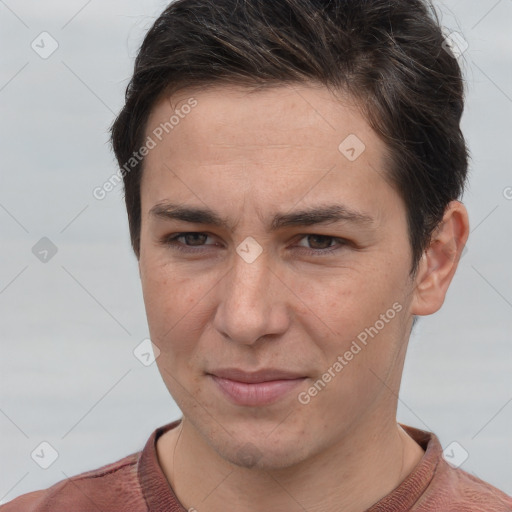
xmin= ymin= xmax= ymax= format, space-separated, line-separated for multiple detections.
xmin=142 ymin=84 xmax=396 ymax=223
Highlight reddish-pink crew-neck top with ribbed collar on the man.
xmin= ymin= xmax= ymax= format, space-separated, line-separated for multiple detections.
xmin=0 ymin=420 xmax=512 ymax=512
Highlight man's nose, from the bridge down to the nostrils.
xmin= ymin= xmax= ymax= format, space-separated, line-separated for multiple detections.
xmin=214 ymin=247 xmax=289 ymax=345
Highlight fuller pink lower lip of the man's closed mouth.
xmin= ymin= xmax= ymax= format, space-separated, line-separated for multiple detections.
xmin=211 ymin=375 xmax=305 ymax=406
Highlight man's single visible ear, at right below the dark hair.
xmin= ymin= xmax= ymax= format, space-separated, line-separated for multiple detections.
xmin=411 ymin=201 xmax=469 ymax=315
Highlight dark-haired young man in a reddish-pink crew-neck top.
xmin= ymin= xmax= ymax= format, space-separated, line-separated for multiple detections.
xmin=2 ymin=0 xmax=512 ymax=512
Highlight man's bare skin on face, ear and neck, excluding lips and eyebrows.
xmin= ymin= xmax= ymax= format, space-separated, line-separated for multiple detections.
xmin=139 ymin=84 xmax=469 ymax=512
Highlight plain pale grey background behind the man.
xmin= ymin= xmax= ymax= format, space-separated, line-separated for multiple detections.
xmin=0 ymin=0 xmax=512 ymax=503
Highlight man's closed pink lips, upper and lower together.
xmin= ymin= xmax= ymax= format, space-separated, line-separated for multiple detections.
xmin=209 ymin=368 xmax=306 ymax=407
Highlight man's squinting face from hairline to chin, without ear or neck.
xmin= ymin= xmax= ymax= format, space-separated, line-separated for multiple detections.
xmin=139 ymin=85 xmax=420 ymax=468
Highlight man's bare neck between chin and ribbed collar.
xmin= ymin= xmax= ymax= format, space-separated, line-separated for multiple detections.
xmin=157 ymin=419 xmax=424 ymax=512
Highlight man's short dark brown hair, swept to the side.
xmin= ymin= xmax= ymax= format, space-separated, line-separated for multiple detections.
xmin=112 ymin=0 xmax=468 ymax=273
